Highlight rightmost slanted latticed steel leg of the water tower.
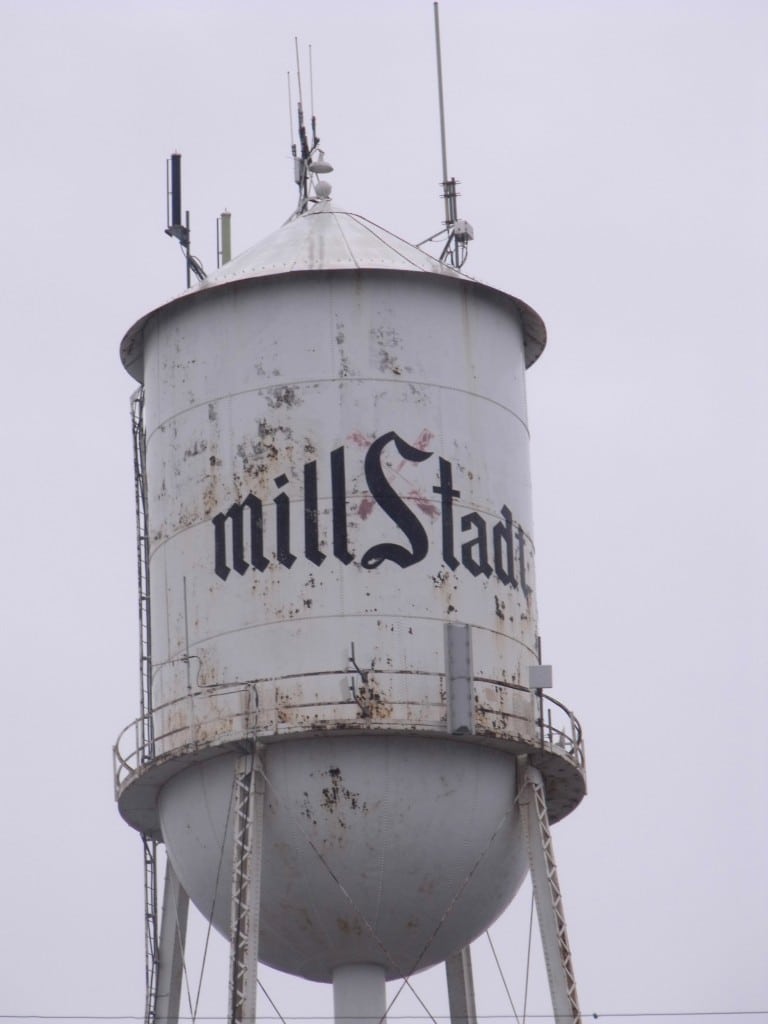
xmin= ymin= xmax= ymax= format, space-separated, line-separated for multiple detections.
xmin=519 ymin=765 xmax=582 ymax=1024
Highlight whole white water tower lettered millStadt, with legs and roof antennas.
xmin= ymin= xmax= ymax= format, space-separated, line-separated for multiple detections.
xmin=116 ymin=18 xmax=585 ymax=1021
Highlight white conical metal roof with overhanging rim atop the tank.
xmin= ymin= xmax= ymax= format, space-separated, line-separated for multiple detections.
xmin=120 ymin=199 xmax=547 ymax=381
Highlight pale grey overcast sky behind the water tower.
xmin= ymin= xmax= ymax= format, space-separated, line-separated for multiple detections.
xmin=0 ymin=0 xmax=768 ymax=1024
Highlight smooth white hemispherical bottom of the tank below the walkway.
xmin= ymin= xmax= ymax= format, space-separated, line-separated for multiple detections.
xmin=159 ymin=735 xmax=527 ymax=982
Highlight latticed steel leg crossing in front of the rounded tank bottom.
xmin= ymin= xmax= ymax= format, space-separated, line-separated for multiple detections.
xmin=229 ymin=750 xmax=264 ymax=1024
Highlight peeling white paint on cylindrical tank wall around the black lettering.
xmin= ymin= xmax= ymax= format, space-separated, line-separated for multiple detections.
xmin=134 ymin=214 xmax=548 ymax=753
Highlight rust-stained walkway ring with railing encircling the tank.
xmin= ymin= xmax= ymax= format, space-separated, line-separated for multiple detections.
xmin=114 ymin=676 xmax=586 ymax=834
